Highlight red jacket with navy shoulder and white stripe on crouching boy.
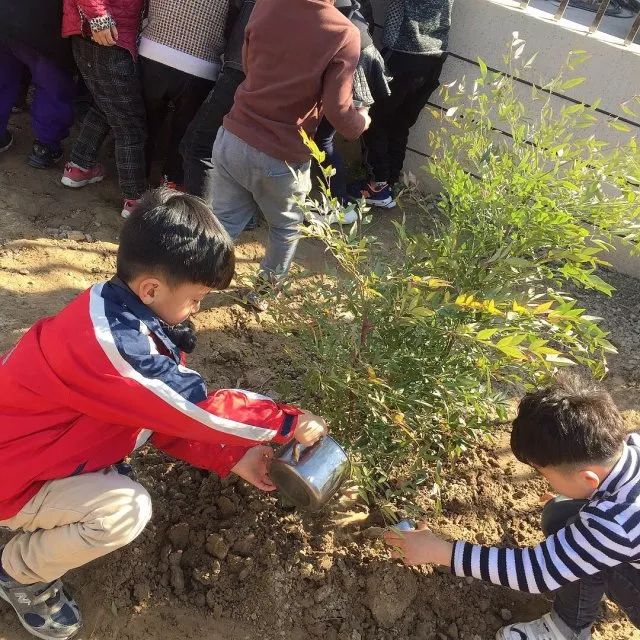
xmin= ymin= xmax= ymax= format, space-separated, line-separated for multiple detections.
xmin=0 ymin=281 xmax=301 ymax=520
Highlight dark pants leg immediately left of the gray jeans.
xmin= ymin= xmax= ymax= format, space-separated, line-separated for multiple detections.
xmin=180 ymin=67 xmax=244 ymax=202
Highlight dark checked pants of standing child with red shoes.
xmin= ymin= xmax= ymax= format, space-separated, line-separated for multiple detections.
xmin=71 ymin=36 xmax=147 ymax=200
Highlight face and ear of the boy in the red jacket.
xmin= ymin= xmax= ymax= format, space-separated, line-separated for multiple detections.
xmin=132 ymin=277 xmax=212 ymax=325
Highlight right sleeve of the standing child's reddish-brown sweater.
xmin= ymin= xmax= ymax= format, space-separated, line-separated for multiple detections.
xmin=322 ymin=27 xmax=365 ymax=140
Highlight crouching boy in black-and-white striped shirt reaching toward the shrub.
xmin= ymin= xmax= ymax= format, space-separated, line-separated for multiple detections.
xmin=386 ymin=380 xmax=640 ymax=640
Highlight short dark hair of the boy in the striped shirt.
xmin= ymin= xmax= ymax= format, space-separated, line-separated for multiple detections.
xmin=511 ymin=378 xmax=627 ymax=467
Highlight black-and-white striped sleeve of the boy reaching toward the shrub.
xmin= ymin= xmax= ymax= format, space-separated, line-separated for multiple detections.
xmin=451 ymin=514 xmax=640 ymax=593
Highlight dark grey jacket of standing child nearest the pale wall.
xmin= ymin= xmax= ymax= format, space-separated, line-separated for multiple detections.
xmin=383 ymin=0 xmax=453 ymax=56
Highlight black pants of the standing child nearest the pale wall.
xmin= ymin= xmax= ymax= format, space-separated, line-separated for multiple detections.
xmin=362 ymin=51 xmax=445 ymax=184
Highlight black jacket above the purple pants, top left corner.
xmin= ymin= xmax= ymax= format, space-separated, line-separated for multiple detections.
xmin=0 ymin=0 xmax=74 ymax=69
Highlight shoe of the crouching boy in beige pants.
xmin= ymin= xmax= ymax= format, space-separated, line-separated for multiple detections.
xmin=0 ymin=548 xmax=82 ymax=640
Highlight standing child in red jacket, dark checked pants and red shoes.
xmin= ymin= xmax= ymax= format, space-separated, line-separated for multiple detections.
xmin=62 ymin=0 xmax=147 ymax=217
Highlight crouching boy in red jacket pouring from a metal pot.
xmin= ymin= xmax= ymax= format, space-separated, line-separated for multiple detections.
xmin=0 ymin=190 xmax=326 ymax=639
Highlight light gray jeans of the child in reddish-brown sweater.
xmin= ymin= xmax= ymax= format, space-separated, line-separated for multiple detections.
xmin=211 ymin=127 xmax=311 ymax=281
